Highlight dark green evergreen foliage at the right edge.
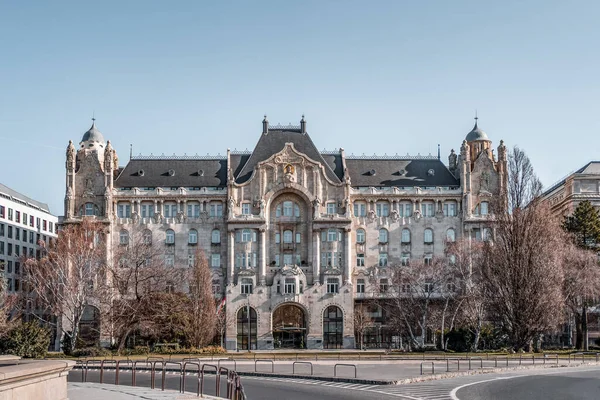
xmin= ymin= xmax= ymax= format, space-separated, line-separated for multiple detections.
xmin=563 ymin=200 xmax=600 ymax=249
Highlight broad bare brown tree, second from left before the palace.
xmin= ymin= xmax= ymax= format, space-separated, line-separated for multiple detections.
xmin=101 ymin=225 xmax=184 ymax=350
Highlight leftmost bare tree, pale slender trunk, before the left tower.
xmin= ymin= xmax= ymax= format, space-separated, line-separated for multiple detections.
xmin=24 ymin=219 xmax=105 ymax=353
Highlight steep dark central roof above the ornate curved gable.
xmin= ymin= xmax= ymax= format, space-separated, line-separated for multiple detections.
xmin=235 ymin=127 xmax=341 ymax=183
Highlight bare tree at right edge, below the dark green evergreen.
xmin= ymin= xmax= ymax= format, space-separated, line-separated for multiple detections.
xmin=563 ymin=243 xmax=600 ymax=351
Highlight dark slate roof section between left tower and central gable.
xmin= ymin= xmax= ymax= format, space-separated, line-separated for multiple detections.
xmin=114 ymin=157 xmax=227 ymax=188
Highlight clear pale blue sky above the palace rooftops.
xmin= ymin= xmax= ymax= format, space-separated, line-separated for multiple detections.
xmin=0 ymin=0 xmax=600 ymax=215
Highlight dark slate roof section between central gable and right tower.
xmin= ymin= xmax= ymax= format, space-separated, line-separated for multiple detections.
xmin=346 ymin=157 xmax=460 ymax=187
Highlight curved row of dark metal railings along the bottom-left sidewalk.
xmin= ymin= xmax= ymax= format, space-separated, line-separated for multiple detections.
xmin=75 ymin=357 xmax=246 ymax=400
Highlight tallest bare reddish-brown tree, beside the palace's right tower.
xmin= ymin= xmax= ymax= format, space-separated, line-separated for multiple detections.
xmin=481 ymin=148 xmax=565 ymax=349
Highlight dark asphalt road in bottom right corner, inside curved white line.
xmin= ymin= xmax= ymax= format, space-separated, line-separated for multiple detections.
xmin=455 ymin=368 xmax=600 ymax=400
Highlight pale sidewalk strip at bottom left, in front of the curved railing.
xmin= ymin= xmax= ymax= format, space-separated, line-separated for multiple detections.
xmin=68 ymin=382 xmax=219 ymax=400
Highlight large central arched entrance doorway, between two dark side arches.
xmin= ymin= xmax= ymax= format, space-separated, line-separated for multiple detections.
xmin=273 ymin=304 xmax=306 ymax=349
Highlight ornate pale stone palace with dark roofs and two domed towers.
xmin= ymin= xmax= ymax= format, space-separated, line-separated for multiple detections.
xmin=64 ymin=116 xmax=507 ymax=350
